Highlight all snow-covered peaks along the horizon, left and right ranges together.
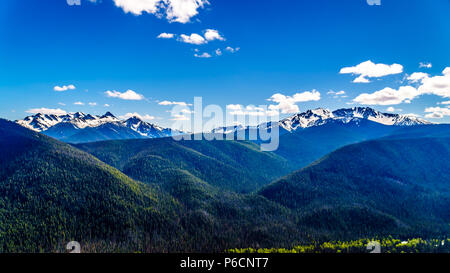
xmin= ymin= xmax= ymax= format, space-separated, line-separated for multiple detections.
xmin=16 ymin=107 xmax=431 ymax=139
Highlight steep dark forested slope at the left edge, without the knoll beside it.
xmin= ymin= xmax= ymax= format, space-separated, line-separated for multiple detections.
xmin=0 ymin=120 xmax=178 ymax=252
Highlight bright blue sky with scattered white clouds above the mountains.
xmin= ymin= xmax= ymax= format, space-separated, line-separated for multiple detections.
xmin=0 ymin=0 xmax=450 ymax=127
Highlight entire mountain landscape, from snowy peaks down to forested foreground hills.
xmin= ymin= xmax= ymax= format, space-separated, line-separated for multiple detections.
xmin=0 ymin=105 xmax=450 ymax=252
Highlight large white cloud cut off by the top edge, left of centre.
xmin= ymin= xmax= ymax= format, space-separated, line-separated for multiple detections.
xmin=114 ymin=0 xmax=209 ymax=24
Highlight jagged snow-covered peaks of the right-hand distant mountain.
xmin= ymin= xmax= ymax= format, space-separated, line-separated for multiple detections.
xmin=278 ymin=107 xmax=431 ymax=131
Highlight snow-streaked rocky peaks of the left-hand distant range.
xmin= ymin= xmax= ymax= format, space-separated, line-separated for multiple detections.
xmin=16 ymin=112 xmax=180 ymax=138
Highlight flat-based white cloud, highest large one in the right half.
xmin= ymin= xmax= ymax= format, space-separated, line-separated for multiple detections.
xmin=339 ymin=61 xmax=403 ymax=83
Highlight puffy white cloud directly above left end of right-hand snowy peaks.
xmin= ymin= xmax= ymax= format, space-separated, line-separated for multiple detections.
xmin=268 ymin=90 xmax=320 ymax=114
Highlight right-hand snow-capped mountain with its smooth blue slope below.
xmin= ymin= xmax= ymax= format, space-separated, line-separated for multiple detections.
xmin=211 ymin=107 xmax=432 ymax=168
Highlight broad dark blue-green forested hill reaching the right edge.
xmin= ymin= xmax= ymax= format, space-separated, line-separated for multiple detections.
xmin=260 ymin=138 xmax=450 ymax=237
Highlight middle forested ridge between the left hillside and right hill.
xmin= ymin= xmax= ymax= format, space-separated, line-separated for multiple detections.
xmin=77 ymin=138 xmax=294 ymax=192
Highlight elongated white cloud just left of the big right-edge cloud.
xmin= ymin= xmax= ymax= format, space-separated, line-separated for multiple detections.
xmin=353 ymin=86 xmax=420 ymax=105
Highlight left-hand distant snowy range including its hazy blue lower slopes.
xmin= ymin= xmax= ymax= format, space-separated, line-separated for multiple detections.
xmin=16 ymin=112 xmax=180 ymax=143
